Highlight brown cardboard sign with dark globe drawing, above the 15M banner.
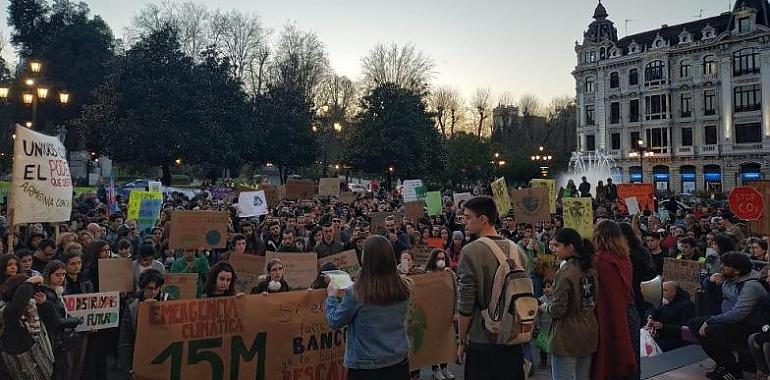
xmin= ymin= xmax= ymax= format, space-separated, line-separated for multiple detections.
xmin=168 ymin=210 xmax=228 ymax=249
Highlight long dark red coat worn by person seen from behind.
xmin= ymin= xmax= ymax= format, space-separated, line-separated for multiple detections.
xmin=591 ymin=251 xmax=639 ymax=380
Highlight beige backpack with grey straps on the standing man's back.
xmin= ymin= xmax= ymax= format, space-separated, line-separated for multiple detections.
xmin=479 ymin=237 xmax=538 ymax=345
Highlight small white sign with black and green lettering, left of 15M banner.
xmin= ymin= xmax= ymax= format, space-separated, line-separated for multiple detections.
xmin=62 ymin=292 xmax=120 ymax=332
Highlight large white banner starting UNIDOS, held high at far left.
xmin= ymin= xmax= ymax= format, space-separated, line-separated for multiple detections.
xmin=9 ymin=125 xmax=72 ymax=224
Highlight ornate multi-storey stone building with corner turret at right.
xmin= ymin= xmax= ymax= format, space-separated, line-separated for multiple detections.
xmin=572 ymin=0 xmax=770 ymax=193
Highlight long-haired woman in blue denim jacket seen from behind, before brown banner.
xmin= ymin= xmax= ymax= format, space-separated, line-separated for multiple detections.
xmin=326 ymin=235 xmax=411 ymax=380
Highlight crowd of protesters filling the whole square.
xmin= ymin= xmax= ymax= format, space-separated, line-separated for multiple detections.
xmin=0 ymin=179 xmax=770 ymax=380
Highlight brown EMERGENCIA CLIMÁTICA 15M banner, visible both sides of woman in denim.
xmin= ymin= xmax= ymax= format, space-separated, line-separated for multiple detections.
xmin=133 ymin=272 xmax=457 ymax=380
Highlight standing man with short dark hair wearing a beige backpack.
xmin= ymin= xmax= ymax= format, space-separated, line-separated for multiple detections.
xmin=457 ymin=197 xmax=538 ymax=380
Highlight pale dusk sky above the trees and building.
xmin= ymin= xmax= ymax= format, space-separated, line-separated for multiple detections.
xmin=0 ymin=0 xmax=732 ymax=101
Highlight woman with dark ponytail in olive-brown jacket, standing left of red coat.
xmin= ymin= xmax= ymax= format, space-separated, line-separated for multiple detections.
xmin=540 ymin=228 xmax=599 ymax=380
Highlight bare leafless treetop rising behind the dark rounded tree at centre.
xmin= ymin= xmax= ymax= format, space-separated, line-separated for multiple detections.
xmin=361 ymin=43 xmax=434 ymax=93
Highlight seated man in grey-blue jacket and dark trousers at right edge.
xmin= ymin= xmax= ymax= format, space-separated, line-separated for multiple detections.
xmin=688 ymin=252 xmax=770 ymax=380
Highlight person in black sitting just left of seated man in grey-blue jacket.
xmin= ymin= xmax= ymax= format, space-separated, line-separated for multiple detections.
xmin=646 ymin=281 xmax=695 ymax=352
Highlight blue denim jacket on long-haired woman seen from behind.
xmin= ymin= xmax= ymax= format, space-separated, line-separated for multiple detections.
xmin=326 ymin=289 xmax=409 ymax=369
